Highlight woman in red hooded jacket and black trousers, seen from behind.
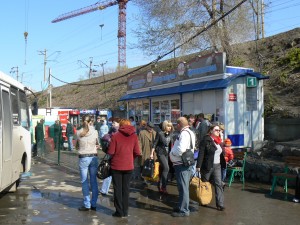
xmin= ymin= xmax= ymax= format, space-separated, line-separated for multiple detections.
xmin=107 ymin=119 xmax=141 ymax=217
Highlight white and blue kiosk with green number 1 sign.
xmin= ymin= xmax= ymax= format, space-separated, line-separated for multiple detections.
xmin=120 ymin=53 xmax=268 ymax=148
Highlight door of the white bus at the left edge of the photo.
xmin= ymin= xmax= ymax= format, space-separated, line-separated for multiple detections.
xmin=0 ymin=86 xmax=13 ymax=188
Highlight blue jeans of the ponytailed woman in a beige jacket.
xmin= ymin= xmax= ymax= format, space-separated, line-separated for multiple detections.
xmin=79 ymin=156 xmax=98 ymax=208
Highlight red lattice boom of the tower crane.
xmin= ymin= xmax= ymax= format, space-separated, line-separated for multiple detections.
xmin=51 ymin=0 xmax=119 ymax=23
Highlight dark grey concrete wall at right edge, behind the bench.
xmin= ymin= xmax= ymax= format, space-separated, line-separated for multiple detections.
xmin=265 ymin=118 xmax=300 ymax=142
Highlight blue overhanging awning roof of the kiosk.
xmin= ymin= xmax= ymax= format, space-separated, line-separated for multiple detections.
xmin=119 ymin=71 xmax=269 ymax=101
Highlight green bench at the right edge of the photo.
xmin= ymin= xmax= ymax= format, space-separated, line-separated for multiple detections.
xmin=270 ymin=156 xmax=300 ymax=195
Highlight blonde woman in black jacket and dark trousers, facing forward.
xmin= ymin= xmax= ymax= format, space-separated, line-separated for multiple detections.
xmin=150 ymin=120 xmax=174 ymax=194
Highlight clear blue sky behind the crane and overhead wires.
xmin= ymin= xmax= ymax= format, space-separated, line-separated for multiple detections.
xmin=0 ymin=0 xmax=300 ymax=91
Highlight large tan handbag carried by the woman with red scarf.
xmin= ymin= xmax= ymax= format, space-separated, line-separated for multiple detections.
xmin=189 ymin=172 xmax=212 ymax=205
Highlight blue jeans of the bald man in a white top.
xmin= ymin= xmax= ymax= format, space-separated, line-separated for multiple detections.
xmin=174 ymin=165 xmax=193 ymax=215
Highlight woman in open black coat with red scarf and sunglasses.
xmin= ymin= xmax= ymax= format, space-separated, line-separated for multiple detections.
xmin=196 ymin=125 xmax=226 ymax=211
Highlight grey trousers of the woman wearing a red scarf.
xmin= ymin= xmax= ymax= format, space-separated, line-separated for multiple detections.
xmin=202 ymin=164 xmax=224 ymax=207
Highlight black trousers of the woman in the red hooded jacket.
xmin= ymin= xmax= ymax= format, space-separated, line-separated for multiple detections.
xmin=111 ymin=170 xmax=133 ymax=216
